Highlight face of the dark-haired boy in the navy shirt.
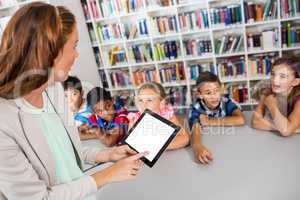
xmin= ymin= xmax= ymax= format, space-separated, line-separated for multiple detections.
xmin=198 ymin=82 xmax=221 ymax=109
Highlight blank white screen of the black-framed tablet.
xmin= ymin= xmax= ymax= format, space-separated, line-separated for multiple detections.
xmin=125 ymin=113 xmax=176 ymax=162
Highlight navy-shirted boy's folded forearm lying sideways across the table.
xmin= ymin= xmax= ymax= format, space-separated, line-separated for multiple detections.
xmin=199 ymin=108 xmax=245 ymax=126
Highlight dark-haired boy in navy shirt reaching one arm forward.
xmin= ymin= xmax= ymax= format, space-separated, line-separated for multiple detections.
xmin=189 ymin=72 xmax=245 ymax=164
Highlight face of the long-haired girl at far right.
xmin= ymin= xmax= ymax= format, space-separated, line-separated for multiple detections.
xmin=270 ymin=64 xmax=299 ymax=95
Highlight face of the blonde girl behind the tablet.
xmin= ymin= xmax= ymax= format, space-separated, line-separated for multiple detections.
xmin=136 ymin=88 xmax=162 ymax=112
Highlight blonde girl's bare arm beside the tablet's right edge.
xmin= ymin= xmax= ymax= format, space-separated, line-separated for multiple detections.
xmin=167 ymin=115 xmax=190 ymax=150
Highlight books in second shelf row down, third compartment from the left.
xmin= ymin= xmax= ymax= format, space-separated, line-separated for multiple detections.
xmin=152 ymin=15 xmax=179 ymax=34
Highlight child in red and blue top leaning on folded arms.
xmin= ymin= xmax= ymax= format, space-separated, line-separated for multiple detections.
xmin=87 ymin=87 xmax=129 ymax=147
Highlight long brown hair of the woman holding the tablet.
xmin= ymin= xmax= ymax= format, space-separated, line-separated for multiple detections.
xmin=0 ymin=2 xmax=76 ymax=99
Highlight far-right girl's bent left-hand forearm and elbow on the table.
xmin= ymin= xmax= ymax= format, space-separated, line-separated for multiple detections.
xmin=251 ymin=95 xmax=275 ymax=131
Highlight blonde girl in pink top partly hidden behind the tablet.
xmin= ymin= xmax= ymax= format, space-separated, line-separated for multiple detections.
xmin=128 ymin=82 xmax=189 ymax=150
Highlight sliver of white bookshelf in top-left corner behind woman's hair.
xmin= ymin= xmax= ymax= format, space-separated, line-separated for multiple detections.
xmin=0 ymin=0 xmax=49 ymax=38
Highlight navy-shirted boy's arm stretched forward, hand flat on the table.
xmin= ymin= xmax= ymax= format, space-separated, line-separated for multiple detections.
xmin=191 ymin=123 xmax=213 ymax=164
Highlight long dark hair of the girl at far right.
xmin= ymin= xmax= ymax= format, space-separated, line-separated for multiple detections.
xmin=271 ymin=55 xmax=300 ymax=113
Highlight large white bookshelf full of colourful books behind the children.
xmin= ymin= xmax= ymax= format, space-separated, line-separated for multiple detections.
xmin=81 ymin=0 xmax=300 ymax=108
